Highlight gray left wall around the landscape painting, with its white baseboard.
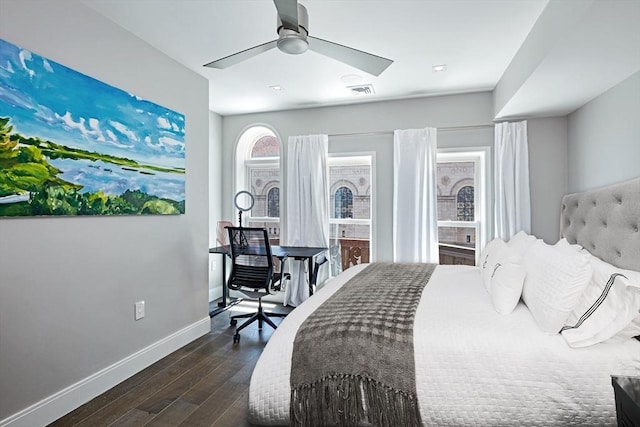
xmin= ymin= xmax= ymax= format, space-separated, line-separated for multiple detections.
xmin=0 ymin=0 xmax=209 ymax=426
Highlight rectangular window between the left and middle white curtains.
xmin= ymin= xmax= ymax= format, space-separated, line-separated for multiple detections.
xmin=328 ymin=154 xmax=374 ymax=274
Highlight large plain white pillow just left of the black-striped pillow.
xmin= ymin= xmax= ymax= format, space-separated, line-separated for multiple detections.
xmin=522 ymin=240 xmax=592 ymax=334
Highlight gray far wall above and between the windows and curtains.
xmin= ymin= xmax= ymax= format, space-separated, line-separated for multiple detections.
xmin=222 ymin=93 xmax=493 ymax=268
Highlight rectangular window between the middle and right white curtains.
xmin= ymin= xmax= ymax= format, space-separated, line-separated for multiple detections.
xmin=436 ymin=149 xmax=488 ymax=265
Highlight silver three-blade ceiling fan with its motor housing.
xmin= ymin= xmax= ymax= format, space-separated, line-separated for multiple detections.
xmin=204 ymin=0 xmax=393 ymax=76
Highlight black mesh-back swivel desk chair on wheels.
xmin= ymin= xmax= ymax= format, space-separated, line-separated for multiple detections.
xmin=227 ymin=227 xmax=290 ymax=343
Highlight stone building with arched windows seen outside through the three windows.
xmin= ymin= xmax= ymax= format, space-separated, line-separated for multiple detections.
xmin=248 ymin=137 xmax=476 ymax=268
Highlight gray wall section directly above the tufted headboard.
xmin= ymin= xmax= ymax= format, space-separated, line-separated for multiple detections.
xmin=568 ymin=72 xmax=640 ymax=192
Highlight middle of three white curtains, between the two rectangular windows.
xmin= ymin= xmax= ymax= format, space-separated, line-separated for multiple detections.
xmin=393 ymin=128 xmax=438 ymax=263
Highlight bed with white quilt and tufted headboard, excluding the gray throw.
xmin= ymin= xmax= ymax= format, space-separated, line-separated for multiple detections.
xmin=249 ymin=179 xmax=640 ymax=426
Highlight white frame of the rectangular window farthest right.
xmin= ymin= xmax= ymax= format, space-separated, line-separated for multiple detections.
xmin=436 ymin=147 xmax=492 ymax=265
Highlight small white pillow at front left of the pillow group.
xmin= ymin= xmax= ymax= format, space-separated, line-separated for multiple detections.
xmin=480 ymin=239 xmax=526 ymax=314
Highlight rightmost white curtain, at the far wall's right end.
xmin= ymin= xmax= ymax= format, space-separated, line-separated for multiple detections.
xmin=494 ymin=120 xmax=531 ymax=241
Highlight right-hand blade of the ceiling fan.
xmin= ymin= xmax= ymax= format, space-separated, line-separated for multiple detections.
xmin=307 ymin=36 xmax=393 ymax=76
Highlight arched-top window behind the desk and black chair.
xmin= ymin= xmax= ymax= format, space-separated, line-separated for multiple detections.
xmin=236 ymin=126 xmax=280 ymax=244
